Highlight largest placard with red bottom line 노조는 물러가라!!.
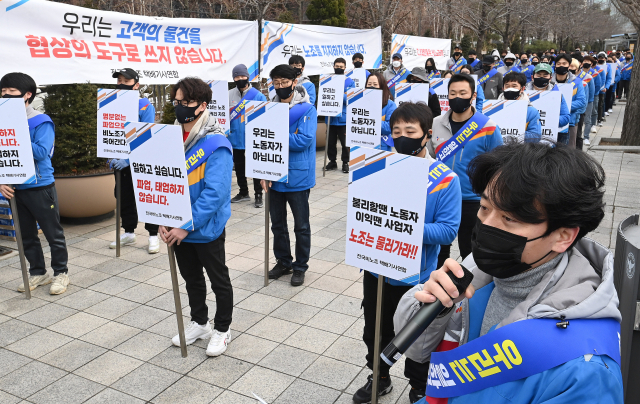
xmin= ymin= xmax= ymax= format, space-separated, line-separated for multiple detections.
xmin=345 ymin=148 xmax=429 ymax=284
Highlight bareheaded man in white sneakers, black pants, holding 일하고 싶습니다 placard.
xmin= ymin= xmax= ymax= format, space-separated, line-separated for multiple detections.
xmin=159 ymin=77 xmax=233 ymax=356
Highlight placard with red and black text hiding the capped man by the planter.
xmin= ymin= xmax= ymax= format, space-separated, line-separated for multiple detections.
xmin=97 ymin=88 xmax=140 ymax=159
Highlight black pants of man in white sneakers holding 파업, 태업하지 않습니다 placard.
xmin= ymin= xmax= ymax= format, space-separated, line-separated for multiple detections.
xmin=175 ymin=231 xmax=233 ymax=332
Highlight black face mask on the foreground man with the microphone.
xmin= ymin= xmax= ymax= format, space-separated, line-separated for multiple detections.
xmin=471 ymin=219 xmax=552 ymax=279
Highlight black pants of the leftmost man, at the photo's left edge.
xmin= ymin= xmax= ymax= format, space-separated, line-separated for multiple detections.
xmin=15 ymin=184 xmax=69 ymax=276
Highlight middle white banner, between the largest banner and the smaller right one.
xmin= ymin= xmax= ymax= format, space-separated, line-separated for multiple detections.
xmin=260 ymin=21 xmax=382 ymax=77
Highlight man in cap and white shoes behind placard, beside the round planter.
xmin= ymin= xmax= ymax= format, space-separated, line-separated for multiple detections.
xmin=109 ymin=68 xmax=160 ymax=254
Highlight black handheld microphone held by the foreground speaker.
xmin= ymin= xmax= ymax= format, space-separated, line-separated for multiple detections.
xmin=380 ymin=265 xmax=473 ymax=366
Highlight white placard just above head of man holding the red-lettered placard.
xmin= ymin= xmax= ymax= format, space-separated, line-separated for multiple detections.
xmin=346 ymin=88 xmax=382 ymax=149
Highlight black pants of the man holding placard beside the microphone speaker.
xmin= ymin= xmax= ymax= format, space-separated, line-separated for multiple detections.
xmin=362 ymin=271 xmax=429 ymax=391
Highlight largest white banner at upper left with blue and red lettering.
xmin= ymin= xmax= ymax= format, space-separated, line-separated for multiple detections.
xmin=0 ymin=0 xmax=258 ymax=85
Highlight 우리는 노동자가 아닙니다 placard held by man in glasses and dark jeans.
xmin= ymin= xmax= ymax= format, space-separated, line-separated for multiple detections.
xmin=244 ymin=101 xmax=289 ymax=182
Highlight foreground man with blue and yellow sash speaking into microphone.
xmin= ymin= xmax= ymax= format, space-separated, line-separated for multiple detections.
xmin=394 ymin=143 xmax=624 ymax=404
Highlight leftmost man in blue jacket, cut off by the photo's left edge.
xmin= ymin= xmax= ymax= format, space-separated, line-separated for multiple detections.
xmin=0 ymin=73 xmax=69 ymax=295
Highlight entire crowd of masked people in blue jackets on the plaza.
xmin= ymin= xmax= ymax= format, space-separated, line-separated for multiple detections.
xmin=0 ymin=41 xmax=633 ymax=404
